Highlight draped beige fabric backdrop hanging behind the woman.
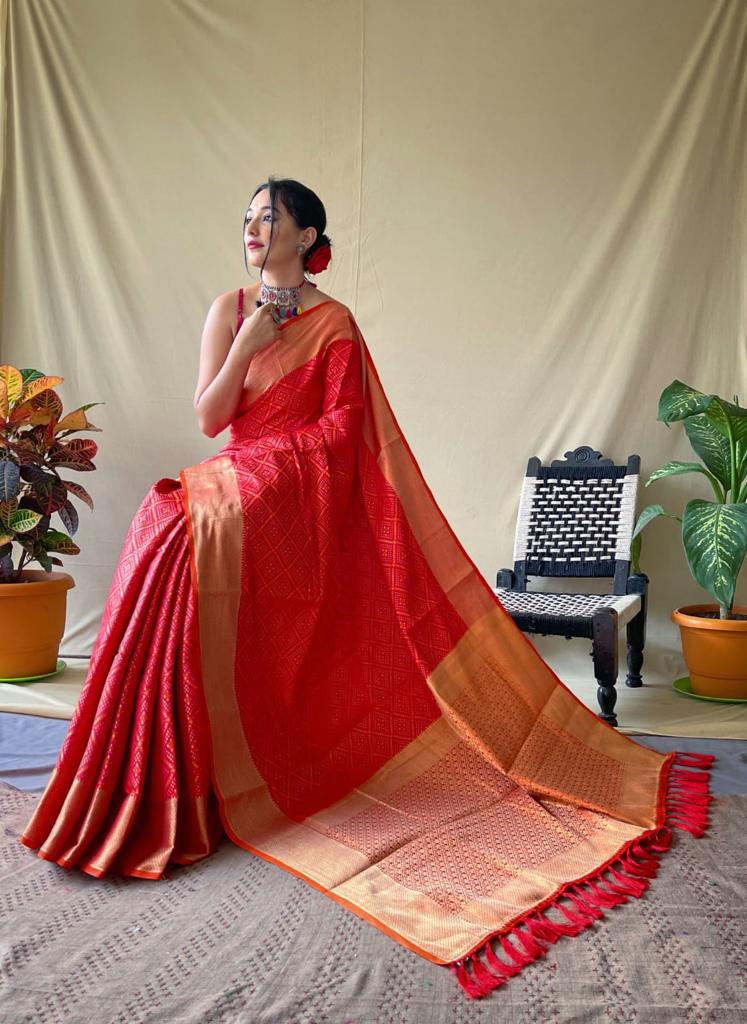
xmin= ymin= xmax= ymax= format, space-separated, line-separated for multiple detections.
xmin=0 ymin=0 xmax=747 ymax=712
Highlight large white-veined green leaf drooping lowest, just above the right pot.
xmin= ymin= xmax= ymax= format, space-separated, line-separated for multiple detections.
xmin=682 ymin=498 xmax=747 ymax=608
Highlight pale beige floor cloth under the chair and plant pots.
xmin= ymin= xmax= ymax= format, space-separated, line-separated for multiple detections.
xmin=0 ymin=636 xmax=747 ymax=739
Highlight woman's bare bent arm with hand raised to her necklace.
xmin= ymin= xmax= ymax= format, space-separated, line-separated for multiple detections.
xmin=194 ymin=292 xmax=261 ymax=437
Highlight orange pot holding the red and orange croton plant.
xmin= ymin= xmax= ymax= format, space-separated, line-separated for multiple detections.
xmin=0 ymin=569 xmax=75 ymax=679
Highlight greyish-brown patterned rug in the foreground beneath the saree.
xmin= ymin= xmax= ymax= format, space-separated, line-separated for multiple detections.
xmin=0 ymin=783 xmax=747 ymax=1024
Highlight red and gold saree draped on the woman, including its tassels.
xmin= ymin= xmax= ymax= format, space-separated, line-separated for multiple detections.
xmin=20 ymin=300 xmax=712 ymax=996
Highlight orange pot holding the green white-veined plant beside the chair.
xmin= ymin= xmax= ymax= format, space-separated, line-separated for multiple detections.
xmin=672 ymin=604 xmax=747 ymax=700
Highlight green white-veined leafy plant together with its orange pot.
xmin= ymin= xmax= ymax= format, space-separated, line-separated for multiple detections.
xmin=631 ymin=380 xmax=747 ymax=699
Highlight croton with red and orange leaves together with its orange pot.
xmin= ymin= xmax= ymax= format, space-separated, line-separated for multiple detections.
xmin=0 ymin=365 xmax=101 ymax=679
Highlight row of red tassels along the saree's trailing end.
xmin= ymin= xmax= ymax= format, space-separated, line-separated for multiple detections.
xmin=449 ymin=754 xmax=715 ymax=999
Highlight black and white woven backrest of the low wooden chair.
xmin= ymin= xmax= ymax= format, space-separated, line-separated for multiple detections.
xmin=513 ymin=446 xmax=640 ymax=594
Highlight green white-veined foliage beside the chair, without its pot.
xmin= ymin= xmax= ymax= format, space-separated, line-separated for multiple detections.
xmin=631 ymin=380 xmax=747 ymax=618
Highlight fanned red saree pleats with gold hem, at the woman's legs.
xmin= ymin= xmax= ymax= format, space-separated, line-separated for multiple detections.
xmin=20 ymin=478 xmax=222 ymax=878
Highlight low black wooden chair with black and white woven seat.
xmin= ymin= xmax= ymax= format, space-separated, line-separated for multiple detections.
xmin=493 ymin=446 xmax=649 ymax=725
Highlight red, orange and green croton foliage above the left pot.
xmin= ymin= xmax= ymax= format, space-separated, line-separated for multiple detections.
xmin=0 ymin=365 xmax=103 ymax=584
